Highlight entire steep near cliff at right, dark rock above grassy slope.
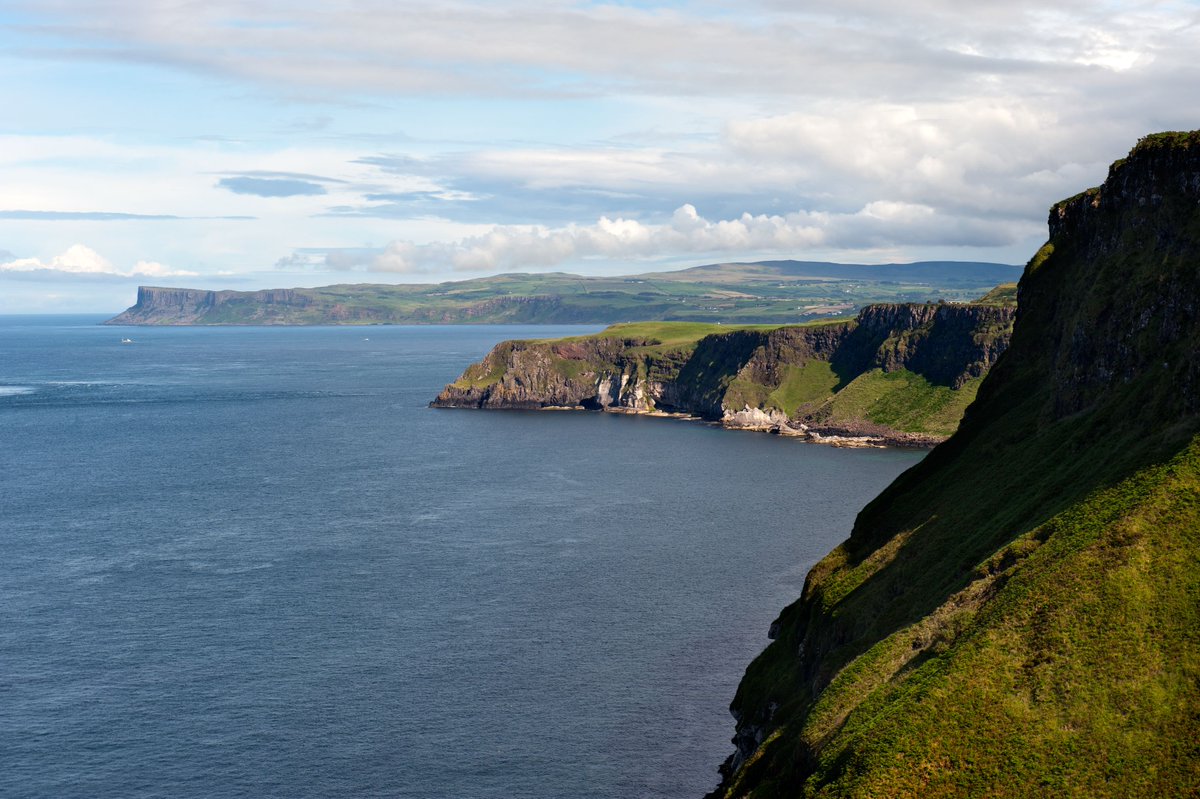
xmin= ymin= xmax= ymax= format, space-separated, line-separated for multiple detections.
xmin=714 ymin=132 xmax=1200 ymax=797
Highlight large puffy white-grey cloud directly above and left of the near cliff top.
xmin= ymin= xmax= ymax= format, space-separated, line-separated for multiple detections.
xmin=725 ymin=97 xmax=1118 ymax=218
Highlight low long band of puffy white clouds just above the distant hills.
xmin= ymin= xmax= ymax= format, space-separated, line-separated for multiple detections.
xmin=304 ymin=202 xmax=1027 ymax=272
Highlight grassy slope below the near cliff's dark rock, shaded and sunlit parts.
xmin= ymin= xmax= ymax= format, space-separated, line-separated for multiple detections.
xmin=731 ymin=385 xmax=1200 ymax=799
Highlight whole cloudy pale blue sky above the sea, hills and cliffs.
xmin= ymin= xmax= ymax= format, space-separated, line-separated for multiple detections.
xmin=0 ymin=0 xmax=1200 ymax=313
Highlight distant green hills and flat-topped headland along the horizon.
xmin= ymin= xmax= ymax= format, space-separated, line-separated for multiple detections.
xmin=107 ymin=260 xmax=1020 ymax=325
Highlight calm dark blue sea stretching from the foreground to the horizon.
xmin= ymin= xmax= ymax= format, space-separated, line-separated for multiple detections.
xmin=0 ymin=317 xmax=922 ymax=799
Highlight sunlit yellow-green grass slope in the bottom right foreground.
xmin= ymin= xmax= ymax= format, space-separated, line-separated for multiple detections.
xmin=805 ymin=443 xmax=1200 ymax=799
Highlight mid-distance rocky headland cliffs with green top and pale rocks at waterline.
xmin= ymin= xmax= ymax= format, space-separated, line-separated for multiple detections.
xmin=432 ymin=299 xmax=1013 ymax=445
